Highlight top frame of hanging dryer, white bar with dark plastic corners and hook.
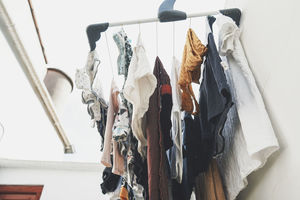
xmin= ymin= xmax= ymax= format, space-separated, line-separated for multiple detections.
xmin=86 ymin=0 xmax=241 ymax=51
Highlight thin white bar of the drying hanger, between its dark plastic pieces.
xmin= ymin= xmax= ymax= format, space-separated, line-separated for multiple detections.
xmin=109 ymin=11 xmax=220 ymax=27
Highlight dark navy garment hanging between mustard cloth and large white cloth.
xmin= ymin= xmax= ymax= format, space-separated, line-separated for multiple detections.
xmin=195 ymin=33 xmax=233 ymax=171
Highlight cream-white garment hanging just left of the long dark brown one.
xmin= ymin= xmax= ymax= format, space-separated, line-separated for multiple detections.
xmin=123 ymin=35 xmax=157 ymax=157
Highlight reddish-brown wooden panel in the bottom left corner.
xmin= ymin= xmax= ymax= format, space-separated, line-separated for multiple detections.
xmin=0 ymin=185 xmax=44 ymax=200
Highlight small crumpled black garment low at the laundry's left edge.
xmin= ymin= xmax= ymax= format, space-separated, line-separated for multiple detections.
xmin=100 ymin=167 xmax=121 ymax=194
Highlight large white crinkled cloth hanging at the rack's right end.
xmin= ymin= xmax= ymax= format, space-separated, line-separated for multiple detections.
xmin=213 ymin=15 xmax=279 ymax=200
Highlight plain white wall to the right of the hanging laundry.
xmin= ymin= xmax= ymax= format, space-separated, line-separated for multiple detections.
xmin=226 ymin=0 xmax=300 ymax=200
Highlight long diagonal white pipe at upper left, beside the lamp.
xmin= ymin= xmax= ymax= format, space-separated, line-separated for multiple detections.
xmin=0 ymin=0 xmax=74 ymax=153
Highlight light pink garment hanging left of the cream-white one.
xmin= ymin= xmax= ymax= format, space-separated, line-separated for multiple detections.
xmin=101 ymin=80 xmax=124 ymax=175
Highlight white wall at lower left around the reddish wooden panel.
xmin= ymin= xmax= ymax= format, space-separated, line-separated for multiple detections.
xmin=0 ymin=160 xmax=109 ymax=200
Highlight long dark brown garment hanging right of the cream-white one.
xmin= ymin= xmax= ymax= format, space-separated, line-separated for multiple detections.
xmin=146 ymin=57 xmax=170 ymax=200
